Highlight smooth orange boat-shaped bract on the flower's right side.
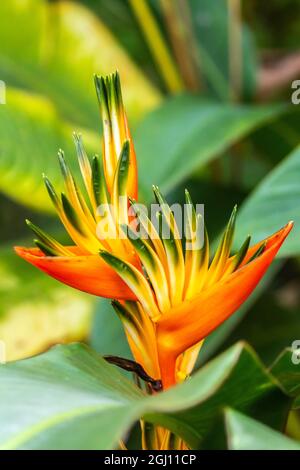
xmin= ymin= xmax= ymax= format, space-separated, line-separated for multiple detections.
xmin=157 ymin=222 xmax=293 ymax=386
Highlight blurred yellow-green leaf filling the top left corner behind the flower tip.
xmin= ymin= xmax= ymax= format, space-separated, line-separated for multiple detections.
xmin=0 ymin=0 xmax=160 ymax=129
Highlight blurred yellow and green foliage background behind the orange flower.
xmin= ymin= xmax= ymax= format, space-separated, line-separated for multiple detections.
xmin=0 ymin=0 xmax=300 ymax=437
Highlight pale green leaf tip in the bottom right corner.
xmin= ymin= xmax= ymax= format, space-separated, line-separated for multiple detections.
xmin=218 ymin=409 xmax=300 ymax=450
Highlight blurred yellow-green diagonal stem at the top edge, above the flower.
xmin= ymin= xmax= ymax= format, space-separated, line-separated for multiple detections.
xmin=129 ymin=0 xmax=184 ymax=94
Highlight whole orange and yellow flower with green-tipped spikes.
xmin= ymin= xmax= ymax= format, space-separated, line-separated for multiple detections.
xmin=16 ymin=70 xmax=292 ymax=392
